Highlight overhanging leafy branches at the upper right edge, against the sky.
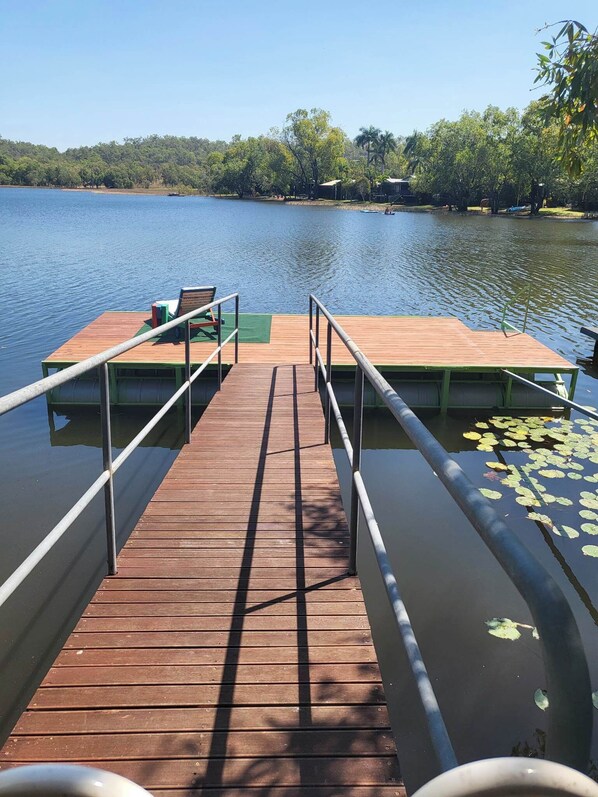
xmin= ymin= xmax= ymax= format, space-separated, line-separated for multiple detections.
xmin=534 ymin=20 xmax=598 ymax=175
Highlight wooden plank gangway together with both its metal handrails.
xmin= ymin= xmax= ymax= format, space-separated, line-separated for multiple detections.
xmin=0 ymin=294 xmax=592 ymax=797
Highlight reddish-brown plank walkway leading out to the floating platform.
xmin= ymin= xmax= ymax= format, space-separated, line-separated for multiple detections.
xmin=0 ymin=364 xmax=404 ymax=797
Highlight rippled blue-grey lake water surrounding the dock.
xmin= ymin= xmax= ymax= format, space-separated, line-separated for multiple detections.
xmin=0 ymin=188 xmax=598 ymax=787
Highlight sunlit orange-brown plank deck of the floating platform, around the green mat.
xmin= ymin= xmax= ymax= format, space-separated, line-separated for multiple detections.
xmin=45 ymin=312 xmax=576 ymax=373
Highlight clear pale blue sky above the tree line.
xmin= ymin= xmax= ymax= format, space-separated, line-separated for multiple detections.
xmin=0 ymin=0 xmax=598 ymax=150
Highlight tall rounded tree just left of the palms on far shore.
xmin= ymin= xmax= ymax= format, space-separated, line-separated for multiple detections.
xmin=281 ymin=108 xmax=344 ymax=198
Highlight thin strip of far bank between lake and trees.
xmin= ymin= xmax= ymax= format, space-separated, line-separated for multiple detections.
xmin=0 ymin=185 xmax=598 ymax=221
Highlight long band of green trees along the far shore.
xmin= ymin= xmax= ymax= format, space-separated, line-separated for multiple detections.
xmin=0 ymin=102 xmax=598 ymax=213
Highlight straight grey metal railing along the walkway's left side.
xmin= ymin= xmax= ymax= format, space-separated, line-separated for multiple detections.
xmin=0 ymin=293 xmax=239 ymax=606
